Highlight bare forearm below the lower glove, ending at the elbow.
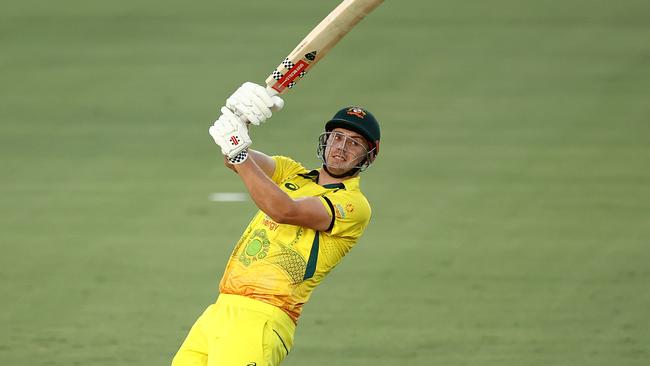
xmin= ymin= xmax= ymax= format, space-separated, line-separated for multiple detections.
xmin=234 ymin=158 xmax=294 ymax=222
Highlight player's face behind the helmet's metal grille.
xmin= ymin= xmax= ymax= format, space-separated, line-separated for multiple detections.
xmin=325 ymin=128 xmax=368 ymax=174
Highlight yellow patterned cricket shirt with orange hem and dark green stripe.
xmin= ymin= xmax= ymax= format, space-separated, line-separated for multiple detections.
xmin=219 ymin=156 xmax=370 ymax=322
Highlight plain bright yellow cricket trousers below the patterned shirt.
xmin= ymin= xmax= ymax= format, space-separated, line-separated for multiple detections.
xmin=172 ymin=294 xmax=295 ymax=366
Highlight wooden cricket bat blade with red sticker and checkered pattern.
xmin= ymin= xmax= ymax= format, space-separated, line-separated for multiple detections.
xmin=266 ymin=0 xmax=384 ymax=94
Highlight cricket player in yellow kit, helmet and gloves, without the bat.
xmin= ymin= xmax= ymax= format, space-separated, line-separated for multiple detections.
xmin=172 ymin=82 xmax=380 ymax=366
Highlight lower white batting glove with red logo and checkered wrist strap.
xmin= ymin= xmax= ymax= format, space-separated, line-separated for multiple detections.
xmin=208 ymin=107 xmax=253 ymax=164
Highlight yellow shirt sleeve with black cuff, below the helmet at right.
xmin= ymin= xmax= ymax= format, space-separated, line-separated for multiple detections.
xmin=321 ymin=190 xmax=371 ymax=239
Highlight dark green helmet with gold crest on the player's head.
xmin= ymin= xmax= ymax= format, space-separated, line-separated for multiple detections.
xmin=325 ymin=106 xmax=381 ymax=159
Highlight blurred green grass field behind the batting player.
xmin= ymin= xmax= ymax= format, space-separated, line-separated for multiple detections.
xmin=0 ymin=0 xmax=650 ymax=366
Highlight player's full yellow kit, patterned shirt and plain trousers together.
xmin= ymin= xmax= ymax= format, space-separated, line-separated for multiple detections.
xmin=173 ymin=156 xmax=370 ymax=366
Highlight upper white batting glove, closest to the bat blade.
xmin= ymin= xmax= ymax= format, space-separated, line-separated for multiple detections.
xmin=226 ymin=81 xmax=284 ymax=125
